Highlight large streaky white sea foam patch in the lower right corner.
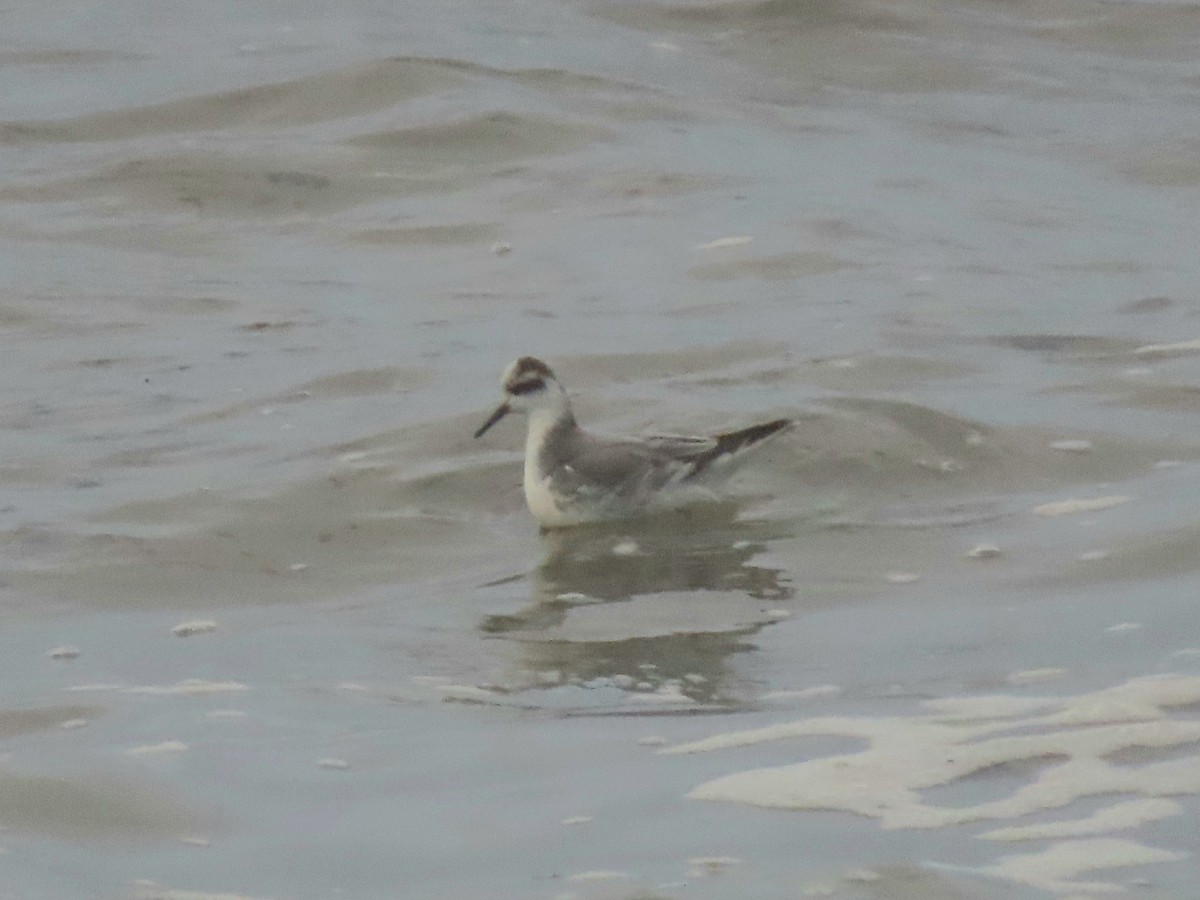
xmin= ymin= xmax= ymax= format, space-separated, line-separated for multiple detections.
xmin=659 ymin=676 xmax=1200 ymax=893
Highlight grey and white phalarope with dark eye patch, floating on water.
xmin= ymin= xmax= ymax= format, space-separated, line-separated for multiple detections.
xmin=475 ymin=356 xmax=792 ymax=528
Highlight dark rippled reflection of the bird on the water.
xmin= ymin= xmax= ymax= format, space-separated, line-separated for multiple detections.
xmin=480 ymin=504 xmax=792 ymax=703
